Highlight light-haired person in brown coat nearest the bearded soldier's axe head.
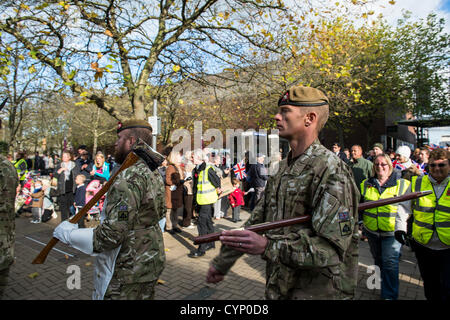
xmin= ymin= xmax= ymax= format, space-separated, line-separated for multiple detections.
xmin=165 ymin=151 xmax=184 ymax=234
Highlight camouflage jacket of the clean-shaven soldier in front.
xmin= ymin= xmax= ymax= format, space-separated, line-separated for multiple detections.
xmin=212 ymin=140 xmax=360 ymax=299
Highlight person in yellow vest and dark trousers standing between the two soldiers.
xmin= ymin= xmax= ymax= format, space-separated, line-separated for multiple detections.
xmin=188 ymin=150 xmax=221 ymax=258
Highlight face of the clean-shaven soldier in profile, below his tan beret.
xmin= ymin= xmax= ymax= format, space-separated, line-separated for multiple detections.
xmin=275 ymin=105 xmax=305 ymax=140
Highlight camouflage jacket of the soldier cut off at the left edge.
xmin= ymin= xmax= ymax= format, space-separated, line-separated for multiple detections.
xmin=0 ymin=155 xmax=19 ymax=270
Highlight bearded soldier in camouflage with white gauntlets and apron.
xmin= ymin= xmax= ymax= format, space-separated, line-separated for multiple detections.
xmin=54 ymin=120 xmax=166 ymax=300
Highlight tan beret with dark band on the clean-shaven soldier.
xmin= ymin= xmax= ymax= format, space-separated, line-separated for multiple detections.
xmin=278 ymin=86 xmax=329 ymax=107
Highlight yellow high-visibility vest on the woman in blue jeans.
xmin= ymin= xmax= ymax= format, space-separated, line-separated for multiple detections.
xmin=361 ymin=179 xmax=410 ymax=232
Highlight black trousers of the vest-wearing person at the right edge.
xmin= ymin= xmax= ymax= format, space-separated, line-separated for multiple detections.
xmin=411 ymin=241 xmax=450 ymax=302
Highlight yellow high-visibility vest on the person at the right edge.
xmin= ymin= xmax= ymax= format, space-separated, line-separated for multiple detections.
xmin=411 ymin=176 xmax=450 ymax=245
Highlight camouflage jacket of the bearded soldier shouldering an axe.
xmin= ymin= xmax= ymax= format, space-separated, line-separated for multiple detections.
xmin=93 ymin=141 xmax=166 ymax=284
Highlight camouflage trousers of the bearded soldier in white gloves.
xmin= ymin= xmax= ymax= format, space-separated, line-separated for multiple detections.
xmin=104 ymin=279 xmax=157 ymax=300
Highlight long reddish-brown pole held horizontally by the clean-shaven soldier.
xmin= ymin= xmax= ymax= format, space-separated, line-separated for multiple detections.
xmin=194 ymin=191 xmax=432 ymax=244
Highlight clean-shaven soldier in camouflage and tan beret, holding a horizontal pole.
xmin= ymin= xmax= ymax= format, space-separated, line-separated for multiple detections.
xmin=207 ymin=86 xmax=359 ymax=299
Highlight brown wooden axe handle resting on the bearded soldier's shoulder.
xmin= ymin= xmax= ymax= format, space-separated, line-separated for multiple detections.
xmin=32 ymin=152 xmax=139 ymax=264
